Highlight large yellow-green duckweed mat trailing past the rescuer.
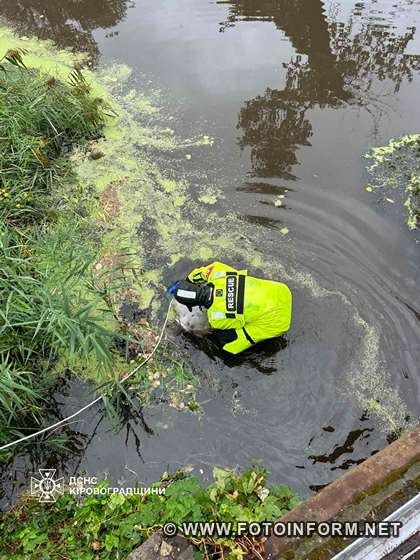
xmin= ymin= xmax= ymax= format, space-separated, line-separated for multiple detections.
xmin=0 ymin=28 xmax=414 ymax=460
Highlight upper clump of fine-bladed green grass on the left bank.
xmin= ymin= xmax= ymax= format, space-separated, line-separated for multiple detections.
xmin=0 ymin=53 xmax=106 ymax=225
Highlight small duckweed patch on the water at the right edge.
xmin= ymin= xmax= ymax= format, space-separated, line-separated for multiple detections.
xmin=365 ymin=134 xmax=420 ymax=230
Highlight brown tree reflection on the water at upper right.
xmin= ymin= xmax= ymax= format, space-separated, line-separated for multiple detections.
xmin=219 ymin=0 xmax=420 ymax=178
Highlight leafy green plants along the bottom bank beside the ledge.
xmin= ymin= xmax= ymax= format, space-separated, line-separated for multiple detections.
xmin=0 ymin=468 xmax=299 ymax=560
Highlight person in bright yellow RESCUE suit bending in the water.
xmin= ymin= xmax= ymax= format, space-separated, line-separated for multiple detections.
xmin=169 ymin=262 xmax=292 ymax=354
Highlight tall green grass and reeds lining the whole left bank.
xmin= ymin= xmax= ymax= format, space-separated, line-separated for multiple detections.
xmin=0 ymin=51 xmax=115 ymax=456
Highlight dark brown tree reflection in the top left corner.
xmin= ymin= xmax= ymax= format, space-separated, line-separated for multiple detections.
xmin=1 ymin=0 xmax=134 ymax=60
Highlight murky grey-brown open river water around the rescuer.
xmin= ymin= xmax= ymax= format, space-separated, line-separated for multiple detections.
xmin=2 ymin=0 xmax=420 ymax=505
